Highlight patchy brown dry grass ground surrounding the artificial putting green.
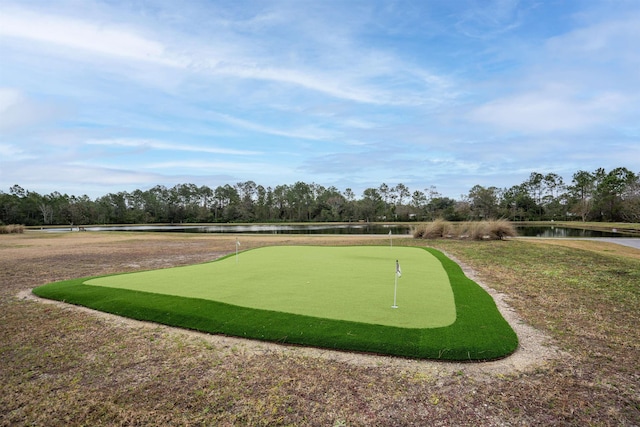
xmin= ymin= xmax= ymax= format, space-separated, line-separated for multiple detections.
xmin=0 ymin=232 xmax=640 ymax=426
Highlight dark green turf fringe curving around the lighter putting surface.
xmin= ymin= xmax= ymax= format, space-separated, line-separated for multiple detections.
xmin=34 ymin=249 xmax=518 ymax=360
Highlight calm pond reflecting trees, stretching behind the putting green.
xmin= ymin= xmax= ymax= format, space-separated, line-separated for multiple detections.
xmin=38 ymin=223 xmax=635 ymax=238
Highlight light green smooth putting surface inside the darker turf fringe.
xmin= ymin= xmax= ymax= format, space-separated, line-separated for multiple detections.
xmin=84 ymin=246 xmax=456 ymax=328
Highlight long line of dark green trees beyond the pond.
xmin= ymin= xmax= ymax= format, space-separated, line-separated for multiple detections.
xmin=0 ymin=167 xmax=640 ymax=226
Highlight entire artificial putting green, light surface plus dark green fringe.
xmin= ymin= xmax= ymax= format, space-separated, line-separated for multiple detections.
xmin=34 ymin=246 xmax=518 ymax=360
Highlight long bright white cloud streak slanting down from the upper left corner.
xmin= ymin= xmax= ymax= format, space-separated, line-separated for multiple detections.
xmin=0 ymin=3 xmax=456 ymax=105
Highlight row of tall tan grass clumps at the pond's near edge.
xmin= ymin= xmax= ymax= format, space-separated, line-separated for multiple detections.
xmin=413 ymin=219 xmax=518 ymax=240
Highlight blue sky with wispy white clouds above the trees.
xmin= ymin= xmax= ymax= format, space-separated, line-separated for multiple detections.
xmin=0 ymin=0 xmax=640 ymax=198
